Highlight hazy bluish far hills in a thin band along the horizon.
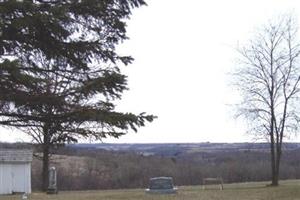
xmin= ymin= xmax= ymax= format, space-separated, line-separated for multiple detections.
xmin=68 ymin=143 xmax=300 ymax=156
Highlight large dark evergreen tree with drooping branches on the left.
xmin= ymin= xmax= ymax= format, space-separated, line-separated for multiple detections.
xmin=0 ymin=0 xmax=154 ymax=189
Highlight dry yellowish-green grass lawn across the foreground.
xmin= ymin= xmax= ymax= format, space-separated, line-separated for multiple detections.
xmin=0 ymin=180 xmax=300 ymax=200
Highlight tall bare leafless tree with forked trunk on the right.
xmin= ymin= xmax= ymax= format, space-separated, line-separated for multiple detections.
xmin=234 ymin=16 xmax=300 ymax=186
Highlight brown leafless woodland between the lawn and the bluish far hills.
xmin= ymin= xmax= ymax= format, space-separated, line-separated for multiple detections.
xmin=32 ymin=147 xmax=300 ymax=190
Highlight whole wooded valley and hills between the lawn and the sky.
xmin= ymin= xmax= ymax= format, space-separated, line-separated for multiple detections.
xmin=0 ymin=143 xmax=300 ymax=190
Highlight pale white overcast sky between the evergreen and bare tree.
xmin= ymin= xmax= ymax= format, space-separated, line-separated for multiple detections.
xmin=0 ymin=0 xmax=300 ymax=143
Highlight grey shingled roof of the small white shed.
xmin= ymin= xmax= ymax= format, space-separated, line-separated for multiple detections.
xmin=0 ymin=149 xmax=33 ymax=163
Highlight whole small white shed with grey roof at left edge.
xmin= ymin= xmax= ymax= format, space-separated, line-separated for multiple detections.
xmin=0 ymin=149 xmax=32 ymax=195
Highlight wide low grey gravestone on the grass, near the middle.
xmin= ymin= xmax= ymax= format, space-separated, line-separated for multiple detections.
xmin=146 ymin=177 xmax=177 ymax=194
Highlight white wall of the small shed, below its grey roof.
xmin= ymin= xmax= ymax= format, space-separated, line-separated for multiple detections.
xmin=0 ymin=163 xmax=31 ymax=194
